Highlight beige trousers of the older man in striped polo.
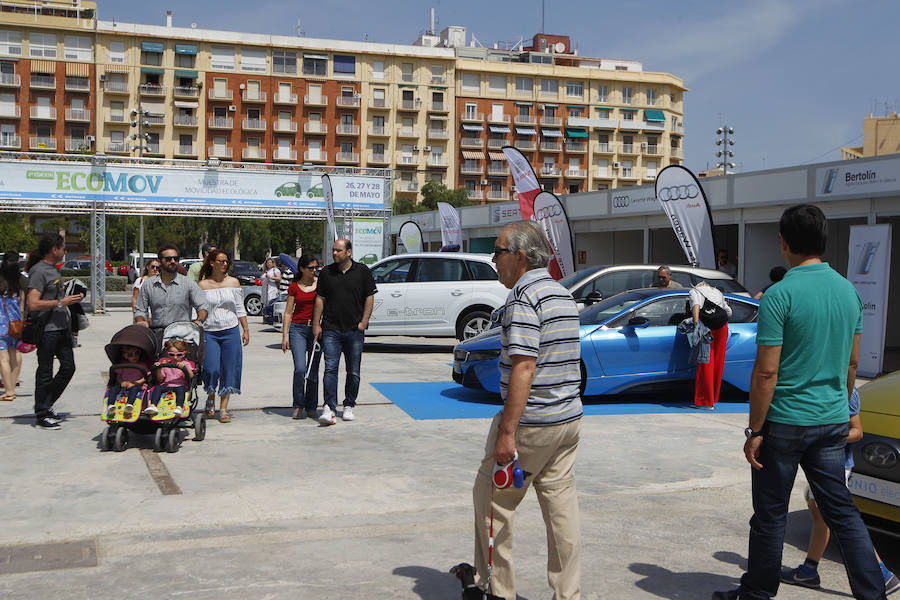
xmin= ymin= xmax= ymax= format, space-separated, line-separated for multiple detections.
xmin=472 ymin=415 xmax=581 ymax=600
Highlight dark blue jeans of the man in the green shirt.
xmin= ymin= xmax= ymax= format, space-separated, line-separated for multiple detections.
xmin=741 ymin=421 xmax=884 ymax=599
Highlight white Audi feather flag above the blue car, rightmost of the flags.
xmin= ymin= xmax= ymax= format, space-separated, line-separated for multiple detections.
xmin=656 ymin=165 xmax=716 ymax=269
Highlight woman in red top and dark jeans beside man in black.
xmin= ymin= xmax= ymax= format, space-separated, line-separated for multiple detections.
xmin=281 ymin=254 xmax=322 ymax=419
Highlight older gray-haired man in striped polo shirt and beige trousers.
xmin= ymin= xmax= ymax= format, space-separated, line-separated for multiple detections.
xmin=472 ymin=221 xmax=582 ymax=600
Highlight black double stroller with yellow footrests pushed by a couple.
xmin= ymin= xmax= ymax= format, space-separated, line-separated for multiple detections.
xmin=100 ymin=321 xmax=206 ymax=452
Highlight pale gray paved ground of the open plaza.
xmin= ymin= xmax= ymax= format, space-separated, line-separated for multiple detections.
xmin=0 ymin=308 xmax=900 ymax=600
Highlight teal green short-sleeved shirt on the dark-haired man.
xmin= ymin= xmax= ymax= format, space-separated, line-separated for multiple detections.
xmin=756 ymin=263 xmax=862 ymax=426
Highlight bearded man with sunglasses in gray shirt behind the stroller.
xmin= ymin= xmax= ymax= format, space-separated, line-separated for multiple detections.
xmin=134 ymin=244 xmax=209 ymax=332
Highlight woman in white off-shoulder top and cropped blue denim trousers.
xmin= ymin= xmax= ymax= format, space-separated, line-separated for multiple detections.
xmin=198 ymin=249 xmax=250 ymax=423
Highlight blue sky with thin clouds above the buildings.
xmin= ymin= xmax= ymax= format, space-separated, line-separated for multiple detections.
xmin=98 ymin=0 xmax=900 ymax=171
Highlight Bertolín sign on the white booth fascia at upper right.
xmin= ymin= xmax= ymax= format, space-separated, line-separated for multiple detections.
xmin=816 ymin=159 xmax=900 ymax=200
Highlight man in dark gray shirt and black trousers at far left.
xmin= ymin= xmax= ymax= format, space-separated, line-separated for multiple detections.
xmin=27 ymin=233 xmax=84 ymax=430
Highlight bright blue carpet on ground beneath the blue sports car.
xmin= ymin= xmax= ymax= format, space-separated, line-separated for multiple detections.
xmin=372 ymin=382 xmax=749 ymax=420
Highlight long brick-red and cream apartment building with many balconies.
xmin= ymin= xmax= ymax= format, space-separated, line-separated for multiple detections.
xmin=0 ymin=0 xmax=685 ymax=202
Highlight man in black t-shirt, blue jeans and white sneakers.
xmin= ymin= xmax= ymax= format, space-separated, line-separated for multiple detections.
xmin=313 ymin=238 xmax=378 ymax=425
